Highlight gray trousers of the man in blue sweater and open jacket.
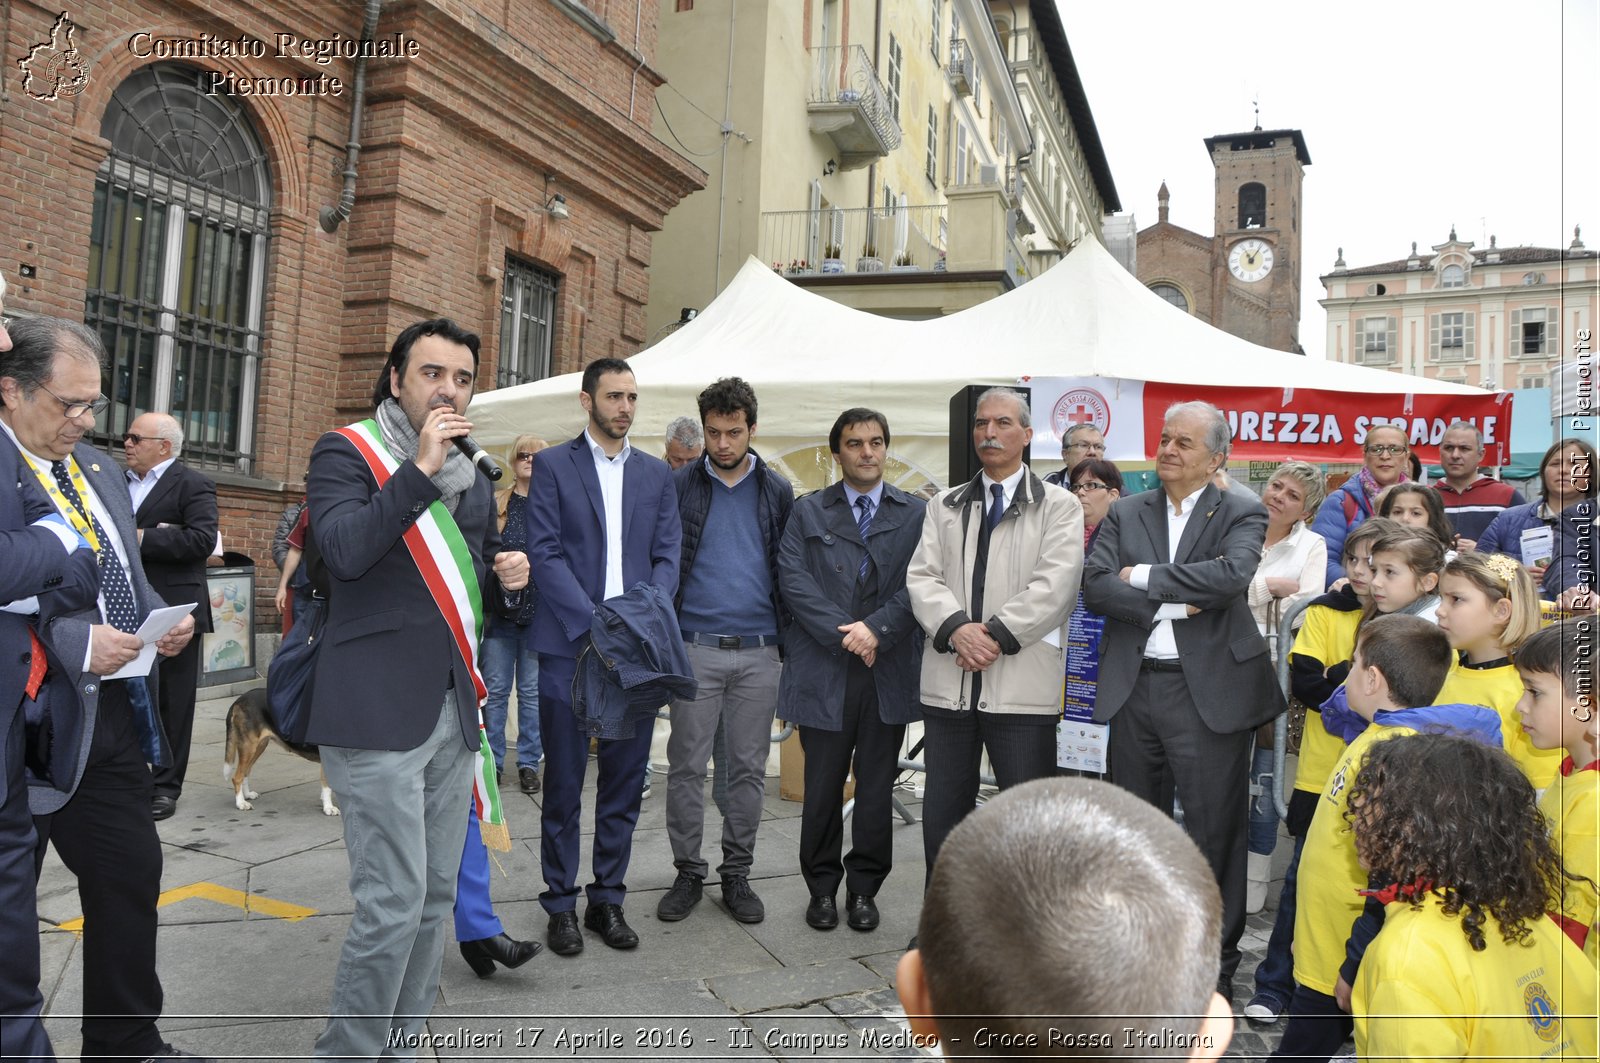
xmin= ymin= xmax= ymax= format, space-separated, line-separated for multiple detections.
xmin=667 ymin=642 xmax=782 ymax=879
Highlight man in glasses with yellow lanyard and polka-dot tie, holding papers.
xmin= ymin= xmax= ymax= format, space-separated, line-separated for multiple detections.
xmin=0 ymin=317 xmax=208 ymax=1060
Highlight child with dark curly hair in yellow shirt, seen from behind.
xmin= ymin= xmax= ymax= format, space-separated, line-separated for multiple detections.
xmin=1346 ymin=735 xmax=1600 ymax=1063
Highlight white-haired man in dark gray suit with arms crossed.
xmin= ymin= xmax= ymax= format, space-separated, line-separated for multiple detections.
xmin=1083 ymin=402 xmax=1283 ymax=999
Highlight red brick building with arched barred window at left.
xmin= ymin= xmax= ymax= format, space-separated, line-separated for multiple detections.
xmin=0 ymin=0 xmax=704 ymax=627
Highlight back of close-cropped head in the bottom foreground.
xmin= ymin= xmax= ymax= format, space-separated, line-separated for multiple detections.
xmin=896 ymin=778 xmax=1234 ymax=1060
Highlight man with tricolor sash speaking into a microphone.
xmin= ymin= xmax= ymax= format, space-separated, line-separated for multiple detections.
xmin=306 ymin=317 xmax=528 ymax=1058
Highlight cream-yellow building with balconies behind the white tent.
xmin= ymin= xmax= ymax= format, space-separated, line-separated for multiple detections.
xmin=648 ymin=0 xmax=1099 ymax=328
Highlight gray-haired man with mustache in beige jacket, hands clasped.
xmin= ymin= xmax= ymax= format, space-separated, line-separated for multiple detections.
xmin=906 ymin=387 xmax=1083 ymax=876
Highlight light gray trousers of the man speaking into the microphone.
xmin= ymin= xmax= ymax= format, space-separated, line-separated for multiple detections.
xmin=315 ymin=693 xmax=472 ymax=1060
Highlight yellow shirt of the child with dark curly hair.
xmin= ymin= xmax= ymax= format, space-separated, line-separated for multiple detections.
xmin=1356 ymin=898 xmax=1600 ymax=1063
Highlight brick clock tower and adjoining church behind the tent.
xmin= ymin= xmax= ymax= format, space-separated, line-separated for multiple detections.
xmin=1138 ymin=126 xmax=1310 ymax=354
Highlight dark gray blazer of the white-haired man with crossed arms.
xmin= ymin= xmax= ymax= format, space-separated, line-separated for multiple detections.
xmin=1083 ymin=483 xmax=1285 ymax=735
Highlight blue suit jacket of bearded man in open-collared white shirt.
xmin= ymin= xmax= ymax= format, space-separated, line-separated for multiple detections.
xmin=528 ymin=434 xmax=683 ymax=658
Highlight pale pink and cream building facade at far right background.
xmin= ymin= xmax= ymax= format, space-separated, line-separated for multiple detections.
xmin=1320 ymin=229 xmax=1600 ymax=391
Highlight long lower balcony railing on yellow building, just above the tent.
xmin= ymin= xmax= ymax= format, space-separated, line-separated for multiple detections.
xmin=760 ymin=205 xmax=949 ymax=274
